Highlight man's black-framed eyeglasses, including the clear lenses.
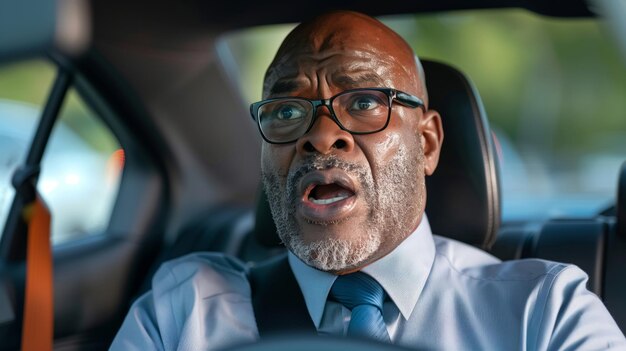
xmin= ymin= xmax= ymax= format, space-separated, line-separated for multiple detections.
xmin=250 ymin=88 xmax=424 ymax=144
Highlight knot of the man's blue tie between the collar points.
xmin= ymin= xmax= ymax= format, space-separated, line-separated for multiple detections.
xmin=330 ymin=272 xmax=385 ymax=311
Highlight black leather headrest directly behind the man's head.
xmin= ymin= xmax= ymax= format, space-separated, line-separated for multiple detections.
xmin=255 ymin=60 xmax=500 ymax=248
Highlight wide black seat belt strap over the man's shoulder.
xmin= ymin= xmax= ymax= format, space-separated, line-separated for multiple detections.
xmin=248 ymin=253 xmax=317 ymax=338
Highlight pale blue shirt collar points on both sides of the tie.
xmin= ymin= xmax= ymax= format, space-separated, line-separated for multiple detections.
xmin=288 ymin=214 xmax=435 ymax=328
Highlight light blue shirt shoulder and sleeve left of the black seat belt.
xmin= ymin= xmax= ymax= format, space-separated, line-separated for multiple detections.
xmin=111 ymin=252 xmax=258 ymax=350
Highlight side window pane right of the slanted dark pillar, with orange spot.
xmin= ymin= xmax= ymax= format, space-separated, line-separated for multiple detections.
xmin=37 ymin=88 xmax=124 ymax=243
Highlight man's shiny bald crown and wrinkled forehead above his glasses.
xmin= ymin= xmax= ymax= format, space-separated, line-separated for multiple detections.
xmin=263 ymin=13 xmax=422 ymax=97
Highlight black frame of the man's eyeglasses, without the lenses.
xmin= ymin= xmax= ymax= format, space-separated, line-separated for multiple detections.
xmin=250 ymin=88 xmax=426 ymax=144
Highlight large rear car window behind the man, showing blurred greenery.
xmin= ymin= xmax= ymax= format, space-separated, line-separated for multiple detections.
xmin=221 ymin=9 xmax=626 ymax=221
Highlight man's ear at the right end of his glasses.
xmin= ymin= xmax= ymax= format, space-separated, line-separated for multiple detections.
xmin=419 ymin=110 xmax=443 ymax=175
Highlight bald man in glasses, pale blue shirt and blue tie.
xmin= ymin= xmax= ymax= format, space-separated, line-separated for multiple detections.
xmin=112 ymin=12 xmax=626 ymax=350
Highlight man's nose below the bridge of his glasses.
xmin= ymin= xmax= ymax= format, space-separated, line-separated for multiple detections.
xmin=296 ymin=106 xmax=354 ymax=155
